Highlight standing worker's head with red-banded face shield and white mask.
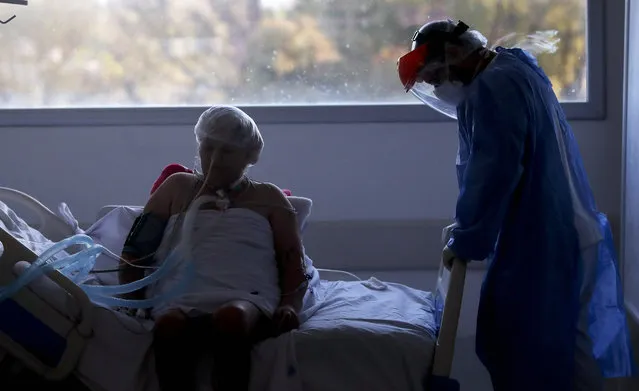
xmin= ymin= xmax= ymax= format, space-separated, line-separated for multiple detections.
xmin=397 ymin=20 xmax=492 ymax=118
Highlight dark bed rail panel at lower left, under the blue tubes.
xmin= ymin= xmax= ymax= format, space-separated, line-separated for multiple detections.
xmin=0 ymin=227 xmax=93 ymax=380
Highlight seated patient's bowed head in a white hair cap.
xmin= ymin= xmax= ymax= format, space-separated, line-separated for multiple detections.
xmin=195 ymin=106 xmax=264 ymax=187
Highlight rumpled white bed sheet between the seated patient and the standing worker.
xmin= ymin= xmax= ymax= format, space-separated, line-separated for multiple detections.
xmin=253 ymin=281 xmax=435 ymax=391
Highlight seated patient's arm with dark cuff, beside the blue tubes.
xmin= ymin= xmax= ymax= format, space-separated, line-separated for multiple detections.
xmin=118 ymin=174 xmax=185 ymax=299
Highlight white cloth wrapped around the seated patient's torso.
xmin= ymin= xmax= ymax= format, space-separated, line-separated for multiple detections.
xmin=147 ymin=208 xmax=280 ymax=317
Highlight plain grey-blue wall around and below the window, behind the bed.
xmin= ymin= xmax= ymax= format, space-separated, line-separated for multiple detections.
xmin=0 ymin=1 xmax=639 ymax=391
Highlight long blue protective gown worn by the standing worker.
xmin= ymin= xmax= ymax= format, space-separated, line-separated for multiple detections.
xmin=448 ymin=48 xmax=634 ymax=391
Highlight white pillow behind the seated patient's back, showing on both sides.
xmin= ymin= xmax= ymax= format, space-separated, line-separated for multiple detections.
xmin=85 ymin=196 xmax=313 ymax=285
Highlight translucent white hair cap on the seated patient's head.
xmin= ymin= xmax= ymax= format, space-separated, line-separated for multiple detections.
xmin=195 ymin=105 xmax=264 ymax=165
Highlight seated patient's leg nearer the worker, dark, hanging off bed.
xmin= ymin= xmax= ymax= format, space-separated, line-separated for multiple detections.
xmin=212 ymin=300 xmax=269 ymax=391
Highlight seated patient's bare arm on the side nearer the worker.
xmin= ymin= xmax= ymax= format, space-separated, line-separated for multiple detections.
xmin=269 ymin=186 xmax=308 ymax=313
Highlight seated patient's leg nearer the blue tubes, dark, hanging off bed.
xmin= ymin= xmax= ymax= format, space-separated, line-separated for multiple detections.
xmin=154 ymin=310 xmax=199 ymax=391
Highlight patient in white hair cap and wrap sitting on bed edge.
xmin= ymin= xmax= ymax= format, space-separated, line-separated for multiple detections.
xmin=119 ymin=106 xmax=307 ymax=390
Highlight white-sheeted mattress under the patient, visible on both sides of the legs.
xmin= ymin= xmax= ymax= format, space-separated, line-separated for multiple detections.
xmin=2 ymin=264 xmax=435 ymax=391
